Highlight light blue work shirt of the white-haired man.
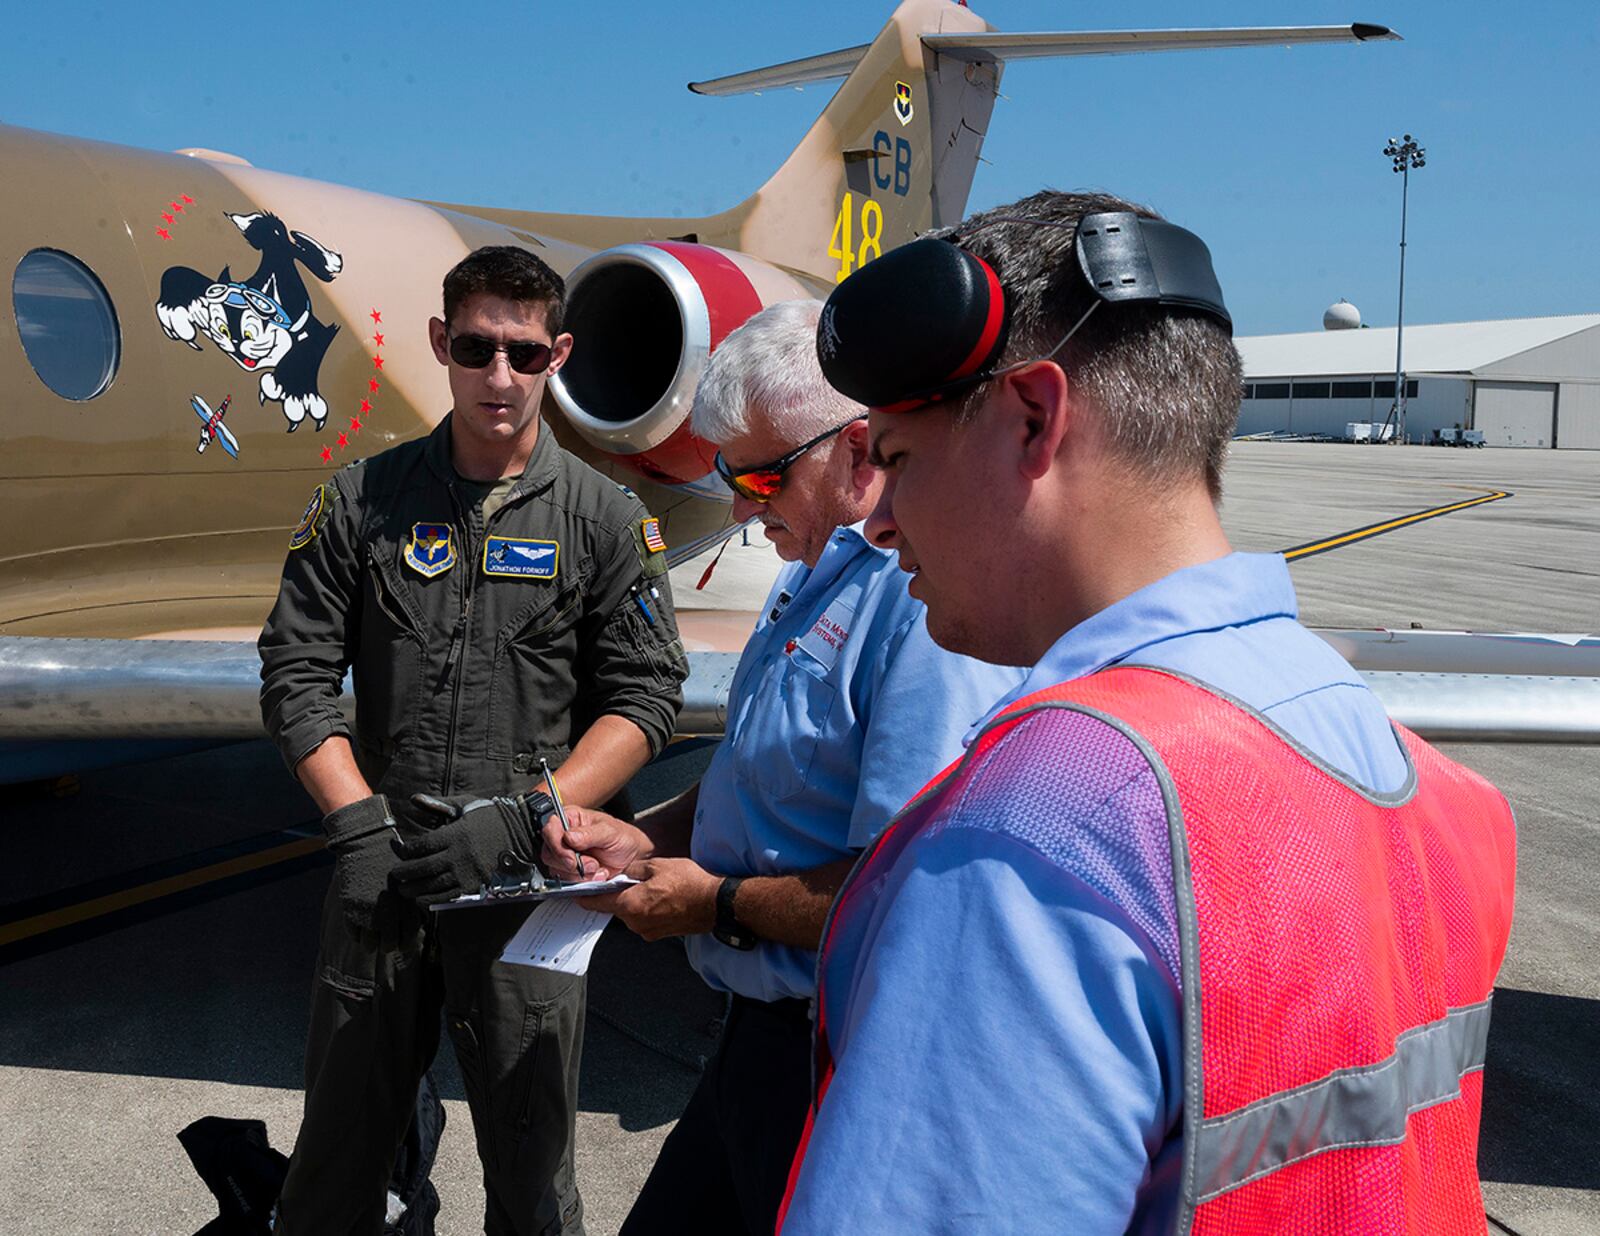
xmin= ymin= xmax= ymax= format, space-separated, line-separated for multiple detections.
xmin=686 ymin=524 xmax=1024 ymax=1001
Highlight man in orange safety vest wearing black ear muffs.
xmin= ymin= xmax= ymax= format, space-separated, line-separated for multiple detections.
xmin=779 ymin=192 xmax=1515 ymax=1236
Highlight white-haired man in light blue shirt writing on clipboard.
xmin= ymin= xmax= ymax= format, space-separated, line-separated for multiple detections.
xmin=544 ymin=301 xmax=1021 ymax=1236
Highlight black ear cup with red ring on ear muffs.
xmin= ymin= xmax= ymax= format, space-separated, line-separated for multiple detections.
xmin=816 ymin=239 xmax=1006 ymax=408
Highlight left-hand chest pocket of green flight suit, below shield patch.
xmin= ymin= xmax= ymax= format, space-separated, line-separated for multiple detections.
xmin=352 ymin=548 xmax=426 ymax=754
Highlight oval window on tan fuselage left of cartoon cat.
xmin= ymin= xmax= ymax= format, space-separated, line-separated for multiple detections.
xmin=11 ymin=248 xmax=122 ymax=402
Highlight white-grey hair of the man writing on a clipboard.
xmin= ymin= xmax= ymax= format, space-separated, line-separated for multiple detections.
xmin=690 ymin=301 xmax=864 ymax=447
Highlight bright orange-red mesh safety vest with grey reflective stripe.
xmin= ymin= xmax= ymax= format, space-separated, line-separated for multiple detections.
xmin=778 ymin=668 xmax=1517 ymax=1236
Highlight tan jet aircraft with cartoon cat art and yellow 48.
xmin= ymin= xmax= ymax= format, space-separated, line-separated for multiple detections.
xmin=0 ymin=0 xmax=1593 ymax=780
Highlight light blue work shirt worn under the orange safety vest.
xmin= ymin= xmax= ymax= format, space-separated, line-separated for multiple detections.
xmin=784 ymin=554 xmax=1411 ymax=1236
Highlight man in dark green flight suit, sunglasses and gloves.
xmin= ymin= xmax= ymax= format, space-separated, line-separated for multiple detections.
xmin=259 ymin=247 xmax=686 ymax=1236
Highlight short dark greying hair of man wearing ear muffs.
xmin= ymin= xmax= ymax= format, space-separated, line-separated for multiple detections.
xmin=946 ymin=189 xmax=1243 ymax=498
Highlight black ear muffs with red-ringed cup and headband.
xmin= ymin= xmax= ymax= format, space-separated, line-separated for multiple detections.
xmin=816 ymin=211 xmax=1234 ymax=411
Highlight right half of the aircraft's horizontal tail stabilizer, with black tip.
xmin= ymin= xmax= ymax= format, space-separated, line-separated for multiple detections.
xmin=922 ymin=22 xmax=1400 ymax=61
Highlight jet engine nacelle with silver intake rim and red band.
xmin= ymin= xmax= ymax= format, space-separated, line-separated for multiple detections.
xmin=550 ymin=240 xmax=810 ymax=501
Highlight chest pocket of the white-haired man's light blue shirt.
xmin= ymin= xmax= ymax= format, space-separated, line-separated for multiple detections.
xmin=738 ymin=645 xmax=838 ymax=802
